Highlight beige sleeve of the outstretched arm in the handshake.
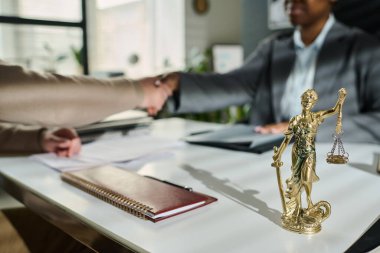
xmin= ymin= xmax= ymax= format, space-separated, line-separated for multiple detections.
xmin=0 ymin=61 xmax=143 ymax=127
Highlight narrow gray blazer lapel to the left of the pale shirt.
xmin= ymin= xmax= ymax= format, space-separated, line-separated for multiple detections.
xmin=271 ymin=36 xmax=295 ymax=122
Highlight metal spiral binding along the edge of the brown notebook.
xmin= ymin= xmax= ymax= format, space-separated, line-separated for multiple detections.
xmin=61 ymin=173 xmax=152 ymax=220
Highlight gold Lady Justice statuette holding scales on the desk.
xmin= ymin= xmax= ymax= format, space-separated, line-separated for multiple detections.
xmin=272 ymin=88 xmax=348 ymax=234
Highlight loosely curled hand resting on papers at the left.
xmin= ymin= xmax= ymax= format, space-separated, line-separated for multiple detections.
xmin=41 ymin=128 xmax=81 ymax=157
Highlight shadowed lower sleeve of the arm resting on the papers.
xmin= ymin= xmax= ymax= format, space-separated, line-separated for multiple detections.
xmin=0 ymin=123 xmax=44 ymax=153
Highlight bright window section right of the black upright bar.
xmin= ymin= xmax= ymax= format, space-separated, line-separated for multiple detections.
xmin=88 ymin=0 xmax=185 ymax=78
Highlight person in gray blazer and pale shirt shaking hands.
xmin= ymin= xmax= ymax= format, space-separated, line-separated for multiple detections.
xmin=152 ymin=0 xmax=380 ymax=143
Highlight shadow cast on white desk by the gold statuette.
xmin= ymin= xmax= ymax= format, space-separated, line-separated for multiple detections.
xmin=180 ymin=164 xmax=281 ymax=227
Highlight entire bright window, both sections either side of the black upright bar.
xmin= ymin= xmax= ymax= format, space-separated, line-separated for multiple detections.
xmin=0 ymin=0 xmax=185 ymax=78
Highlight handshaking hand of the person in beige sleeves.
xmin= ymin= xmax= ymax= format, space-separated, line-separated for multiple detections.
xmin=138 ymin=77 xmax=172 ymax=115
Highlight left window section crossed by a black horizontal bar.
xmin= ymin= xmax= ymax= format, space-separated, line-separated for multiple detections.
xmin=0 ymin=0 xmax=87 ymax=74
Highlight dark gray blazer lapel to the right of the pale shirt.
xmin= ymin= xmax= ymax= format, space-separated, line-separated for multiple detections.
xmin=314 ymin=22 xmax=349 ymax=110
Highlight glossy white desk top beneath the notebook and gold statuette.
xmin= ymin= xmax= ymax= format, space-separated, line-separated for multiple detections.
xmin=0 ymin=119 xmax=380 ymax=253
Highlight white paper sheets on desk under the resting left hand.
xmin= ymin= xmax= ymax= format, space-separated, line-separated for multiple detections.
xmin=31 ymin=135 xmax=185 ymax=171
